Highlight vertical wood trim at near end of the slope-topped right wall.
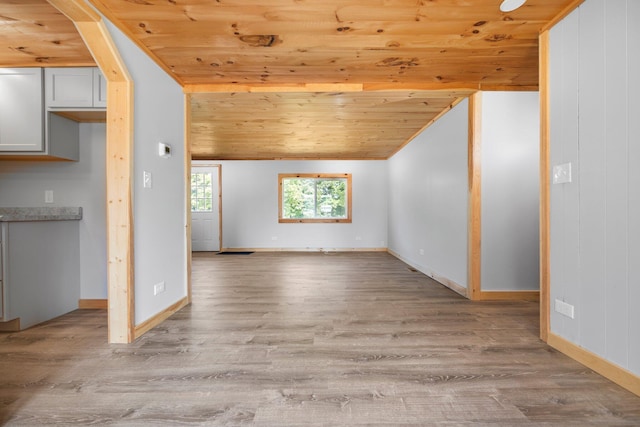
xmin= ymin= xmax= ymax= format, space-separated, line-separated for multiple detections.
xmin=467 ymin=92 xmax=482 ymax=301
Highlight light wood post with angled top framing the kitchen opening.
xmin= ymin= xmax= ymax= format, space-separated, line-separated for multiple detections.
xmin=48 ymin=0 xmax=134 ymax=343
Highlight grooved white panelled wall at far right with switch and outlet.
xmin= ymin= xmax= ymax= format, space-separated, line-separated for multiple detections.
xmin=549 ymin=0 xmax=640 ymax=374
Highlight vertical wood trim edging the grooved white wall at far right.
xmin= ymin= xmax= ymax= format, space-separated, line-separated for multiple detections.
xmin=539 ymin=30 xmax=551 ymax=342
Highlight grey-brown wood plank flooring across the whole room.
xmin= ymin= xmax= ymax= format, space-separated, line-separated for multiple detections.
xmin=0 ymin=253 xmax=640 ymax=426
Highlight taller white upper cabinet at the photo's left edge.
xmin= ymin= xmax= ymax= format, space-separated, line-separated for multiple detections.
xmin=0 ymin=68 xmax=44 ymax=152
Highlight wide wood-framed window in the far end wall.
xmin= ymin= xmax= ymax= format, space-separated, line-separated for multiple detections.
xmin=278 ymin=173 xmax=351 ymax=222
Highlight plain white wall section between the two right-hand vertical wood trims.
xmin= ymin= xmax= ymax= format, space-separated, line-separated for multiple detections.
xmin=481 ymin=92 xmax=540 ymax=291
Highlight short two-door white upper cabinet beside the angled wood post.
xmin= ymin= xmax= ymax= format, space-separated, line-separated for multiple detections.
xmin=45 ymin=67 xmax=107 ymax=109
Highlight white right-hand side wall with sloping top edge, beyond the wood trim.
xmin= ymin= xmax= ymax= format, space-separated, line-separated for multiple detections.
xmin=388 ymin=100 xmax=469 ymax=288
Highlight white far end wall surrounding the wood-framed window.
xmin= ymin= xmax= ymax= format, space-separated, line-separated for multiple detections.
xmin=216 ymin=161 xmax=387 ymax=250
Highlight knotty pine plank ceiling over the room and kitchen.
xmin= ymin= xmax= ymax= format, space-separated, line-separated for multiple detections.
xmin=0 ymin=0 xmax=575 ymax=159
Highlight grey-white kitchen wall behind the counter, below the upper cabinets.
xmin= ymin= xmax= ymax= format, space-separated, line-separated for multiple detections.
xmin=0 ymin=123 xmax=107 ymax=299
